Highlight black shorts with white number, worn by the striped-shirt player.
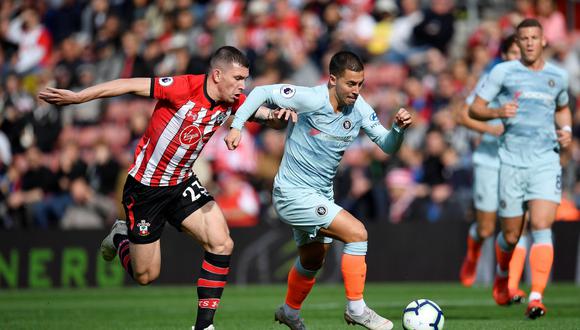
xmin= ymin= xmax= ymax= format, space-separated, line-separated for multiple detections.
xmin=123 ymin=175 xmax=213 ymax=244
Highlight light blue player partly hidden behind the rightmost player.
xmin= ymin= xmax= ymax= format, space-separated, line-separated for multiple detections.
xmin=458 ymin=35 xmax=527 ymax=303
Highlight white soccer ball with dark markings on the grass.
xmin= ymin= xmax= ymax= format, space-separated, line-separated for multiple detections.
xmin=403 ymin=299 xmax=445 ymax=330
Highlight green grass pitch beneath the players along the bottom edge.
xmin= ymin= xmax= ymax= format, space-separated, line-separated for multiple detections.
xmin=0 ymin=283 xmax=580 ymax=330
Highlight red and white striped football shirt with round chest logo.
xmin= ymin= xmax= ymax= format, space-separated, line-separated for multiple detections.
xmin=129 ymin=75 xmax=246 ymax=187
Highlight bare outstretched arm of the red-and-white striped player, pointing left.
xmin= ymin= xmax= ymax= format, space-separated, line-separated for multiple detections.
xmin=38 ymin=78 xmax=151 ymax=105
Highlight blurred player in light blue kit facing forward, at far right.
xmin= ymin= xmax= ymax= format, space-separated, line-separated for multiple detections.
xmin=469 ymin=19 xmax=572 ymax=319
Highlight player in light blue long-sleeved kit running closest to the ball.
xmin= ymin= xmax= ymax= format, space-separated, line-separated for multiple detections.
xmin=225 ymin=52 xmax=411 ymax=329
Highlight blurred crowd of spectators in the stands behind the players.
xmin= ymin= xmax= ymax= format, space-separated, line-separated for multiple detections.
xmin=0 ymin=0 xmax=580 ymax=230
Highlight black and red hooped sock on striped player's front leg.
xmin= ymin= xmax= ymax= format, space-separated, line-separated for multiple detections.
xmin=195 ymin=252 xmax=230 ymax=329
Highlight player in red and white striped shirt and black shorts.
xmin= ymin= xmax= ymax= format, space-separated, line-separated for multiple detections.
xmin=39 ymin=46 xmax=296 ymax=329
